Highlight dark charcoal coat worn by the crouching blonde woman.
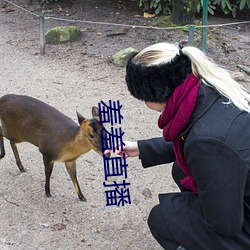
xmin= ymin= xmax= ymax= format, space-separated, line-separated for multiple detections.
xmin=138 ymin=85 xmax=250 ymax=250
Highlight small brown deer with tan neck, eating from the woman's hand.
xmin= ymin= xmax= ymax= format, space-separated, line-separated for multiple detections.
xmin=0 ymin=94 xmax=109 ymax=201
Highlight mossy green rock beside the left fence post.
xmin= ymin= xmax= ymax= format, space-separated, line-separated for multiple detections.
xmin=45 ymin=26 xmax=82 ymax=44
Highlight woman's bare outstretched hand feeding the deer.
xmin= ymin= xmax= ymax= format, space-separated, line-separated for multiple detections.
xmin=104 ymin=141 xmax=140 ymax=158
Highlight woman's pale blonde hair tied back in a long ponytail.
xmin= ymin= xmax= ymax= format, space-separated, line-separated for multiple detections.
xmin=134 ymin=43 xmax=250 ymax=113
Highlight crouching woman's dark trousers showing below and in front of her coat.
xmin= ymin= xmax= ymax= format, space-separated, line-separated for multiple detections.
xmin=148 ymin=162 xmax=188 ymax=250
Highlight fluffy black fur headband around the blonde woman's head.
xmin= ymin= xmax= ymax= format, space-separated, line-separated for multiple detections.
xmin=126 ymin=51 xmax=192 ymax=103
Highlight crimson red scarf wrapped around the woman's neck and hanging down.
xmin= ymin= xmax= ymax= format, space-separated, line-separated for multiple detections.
xmin=158 ymin=73 xmax=200 ymax=194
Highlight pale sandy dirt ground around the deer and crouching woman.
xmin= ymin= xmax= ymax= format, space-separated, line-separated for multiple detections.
xmin=0 ymin=0 xmax=250 ymax=250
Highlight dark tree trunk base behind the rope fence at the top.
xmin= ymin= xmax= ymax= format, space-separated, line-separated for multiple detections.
xmin=171 ymin=0 xmax=198 ymax=25
